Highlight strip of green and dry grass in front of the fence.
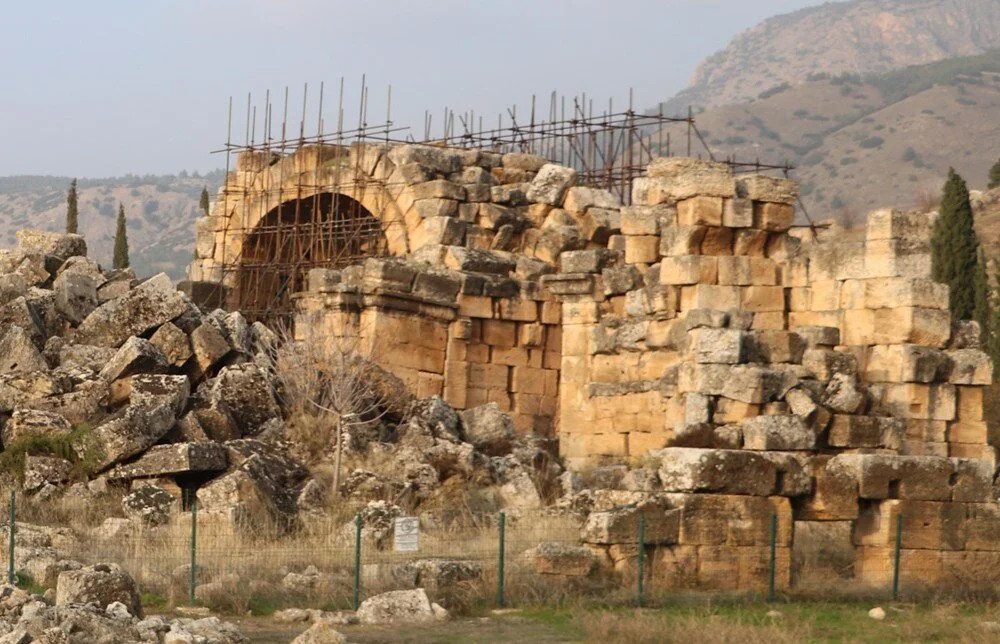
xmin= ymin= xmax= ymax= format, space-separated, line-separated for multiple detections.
xmin=229 ymin=602 xmax=1000 ymax=644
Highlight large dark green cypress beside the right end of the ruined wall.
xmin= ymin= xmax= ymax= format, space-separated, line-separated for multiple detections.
xmin=931 ymin=168 xmax=979 ymax=320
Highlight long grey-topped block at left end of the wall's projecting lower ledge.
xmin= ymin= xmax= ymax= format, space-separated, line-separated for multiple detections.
xmin=650 ymin=447 xmax=778 ymax=496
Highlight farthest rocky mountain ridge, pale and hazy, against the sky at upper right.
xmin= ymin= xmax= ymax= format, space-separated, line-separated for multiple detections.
xmin=665 ymin=0 xmax=1000 ymax=113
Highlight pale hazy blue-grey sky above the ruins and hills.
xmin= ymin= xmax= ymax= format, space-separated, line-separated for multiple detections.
xmin=0 ymin=0 xmax=820 ymax=177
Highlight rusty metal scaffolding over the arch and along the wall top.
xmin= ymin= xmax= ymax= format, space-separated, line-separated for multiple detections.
xmin=205 ymin=77 xmax=792 ymax=322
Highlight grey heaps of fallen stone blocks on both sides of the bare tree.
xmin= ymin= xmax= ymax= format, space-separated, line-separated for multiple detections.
xmin=0 ymin=231 xmax=558 ymax=526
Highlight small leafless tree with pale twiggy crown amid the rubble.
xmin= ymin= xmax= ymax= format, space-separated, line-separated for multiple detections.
xmin=274 ymin=324 xmax=406 ymax=494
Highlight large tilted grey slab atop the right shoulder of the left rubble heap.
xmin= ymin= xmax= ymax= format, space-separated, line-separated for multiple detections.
xmin=76 ymin=273 xmax=188 ymax=347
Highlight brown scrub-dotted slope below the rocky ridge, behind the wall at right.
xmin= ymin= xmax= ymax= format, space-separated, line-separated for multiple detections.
xmin=648 ymin=49 xmax=1000 ymax=223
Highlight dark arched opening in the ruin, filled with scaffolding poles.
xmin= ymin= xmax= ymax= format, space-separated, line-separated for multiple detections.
xmin=228 ymin=192 xmax=389 ymax=323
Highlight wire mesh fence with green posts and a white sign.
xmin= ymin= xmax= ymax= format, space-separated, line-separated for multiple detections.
xmin=3 ymin=495 xmax=1000 ymax=614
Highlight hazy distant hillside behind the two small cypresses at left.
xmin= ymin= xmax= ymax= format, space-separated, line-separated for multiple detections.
xmin=0 ymin=171 xmax=222 ymax=280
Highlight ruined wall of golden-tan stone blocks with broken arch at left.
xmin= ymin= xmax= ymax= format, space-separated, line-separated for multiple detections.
xmin=180 ymin=145 xmax=1000 ymax=586
